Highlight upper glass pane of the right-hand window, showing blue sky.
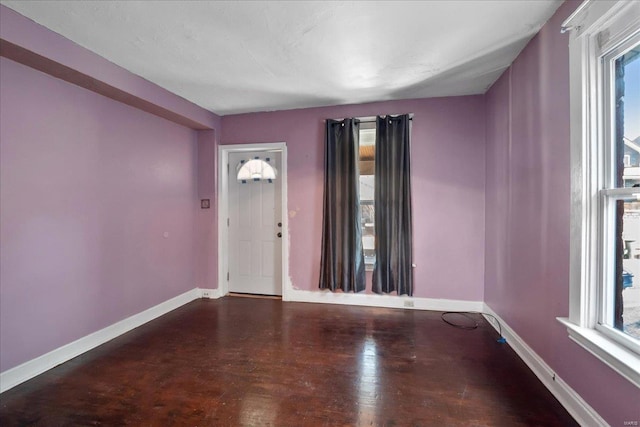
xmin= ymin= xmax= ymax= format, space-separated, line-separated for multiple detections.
xmin=614 ymin=45 xmax=640 ymax=187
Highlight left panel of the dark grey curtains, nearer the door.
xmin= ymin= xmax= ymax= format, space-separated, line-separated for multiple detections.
xmin=320 ymin=119 xmax=365 ymax=292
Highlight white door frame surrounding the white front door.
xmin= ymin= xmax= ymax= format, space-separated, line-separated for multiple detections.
xmin=218 ymin=142 xmax=291 ymax=301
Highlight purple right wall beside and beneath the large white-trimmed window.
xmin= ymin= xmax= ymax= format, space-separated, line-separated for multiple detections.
xmin=485 ymin=2 xmax=640 ymax=426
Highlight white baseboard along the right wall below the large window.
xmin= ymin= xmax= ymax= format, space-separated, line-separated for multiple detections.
xmin=484 ymin=303 xmax=609 ymax=427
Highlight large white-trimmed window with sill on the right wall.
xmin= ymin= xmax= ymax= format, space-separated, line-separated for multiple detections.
xmin=559 ymin=1 xmax=640 ymax=386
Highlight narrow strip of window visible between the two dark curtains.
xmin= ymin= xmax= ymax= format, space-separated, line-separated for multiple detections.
xmin=359 ymin=122 xmax=376 ymax=269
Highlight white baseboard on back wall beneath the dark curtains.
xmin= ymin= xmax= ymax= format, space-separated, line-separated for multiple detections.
xmin=282 ymin=289 xmax=483 ymax=311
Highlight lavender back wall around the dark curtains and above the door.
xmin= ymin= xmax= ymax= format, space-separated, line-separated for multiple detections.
xmin=221 ymin=96 xmax=485 ymax=301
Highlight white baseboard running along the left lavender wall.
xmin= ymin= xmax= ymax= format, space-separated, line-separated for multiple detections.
xmin=0 ymin=288 xmax=202 ymax=393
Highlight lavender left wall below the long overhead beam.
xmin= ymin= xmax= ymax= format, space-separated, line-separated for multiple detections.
xmin=0 ymin=58 xmax=197 ymax=371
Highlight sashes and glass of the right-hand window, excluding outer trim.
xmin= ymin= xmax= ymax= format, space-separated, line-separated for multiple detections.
xmin=597 ymin=38 xmax=640 ymax=354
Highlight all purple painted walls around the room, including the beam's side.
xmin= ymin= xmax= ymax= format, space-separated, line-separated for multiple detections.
xmin=0 ymin=2 xmax=640 ymax=425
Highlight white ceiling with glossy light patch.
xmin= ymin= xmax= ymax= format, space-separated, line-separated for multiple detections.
xmin=1 ymin=0 xmax=562 ymax=115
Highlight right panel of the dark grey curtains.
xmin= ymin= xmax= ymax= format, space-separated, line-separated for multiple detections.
xmin=373 ymin=114 xmax=413 ymax=296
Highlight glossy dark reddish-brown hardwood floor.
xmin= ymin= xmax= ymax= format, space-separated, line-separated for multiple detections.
xmin=0 ymin=297 xmax=576 ymax=427
